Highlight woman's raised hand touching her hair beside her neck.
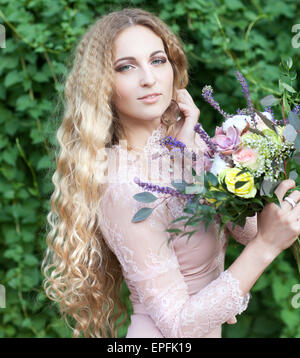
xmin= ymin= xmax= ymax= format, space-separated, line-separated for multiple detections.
xmin=175 ymin=89 xmax=200 ymax=148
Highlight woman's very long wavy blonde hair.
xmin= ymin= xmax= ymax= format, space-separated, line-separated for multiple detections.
xmin=41 ymin=8 xmax=188 ymax=338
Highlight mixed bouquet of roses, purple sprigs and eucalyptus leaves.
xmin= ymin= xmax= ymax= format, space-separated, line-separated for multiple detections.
xmin=132 ymin=60 xmax=300 ymax=273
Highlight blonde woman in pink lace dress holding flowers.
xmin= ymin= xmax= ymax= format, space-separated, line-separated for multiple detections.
xmin=42 ymin=9 xmax=300 ymax=338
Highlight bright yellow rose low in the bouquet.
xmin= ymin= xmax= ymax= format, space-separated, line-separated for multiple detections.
xmin=218 ymin=168 xmax=257 ymax=198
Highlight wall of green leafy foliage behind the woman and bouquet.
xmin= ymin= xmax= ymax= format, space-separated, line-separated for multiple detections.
xmin=0 ymin=0 xmax=300 ymax=338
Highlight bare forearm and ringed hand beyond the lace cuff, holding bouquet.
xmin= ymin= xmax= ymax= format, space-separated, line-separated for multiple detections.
xmin=228 ymin=180 xmax=300 ymax=294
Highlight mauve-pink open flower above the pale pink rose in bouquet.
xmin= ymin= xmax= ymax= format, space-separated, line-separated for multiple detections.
xmin=212 ymin=126 xmax=241 ymax=155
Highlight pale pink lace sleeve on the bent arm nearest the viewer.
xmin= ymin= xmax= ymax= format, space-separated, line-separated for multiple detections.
xmin=99 ymin=184 xmax=250 ymax=338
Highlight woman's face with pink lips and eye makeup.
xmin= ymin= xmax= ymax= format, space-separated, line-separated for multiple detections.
xmin=113 ymin=25 xmax=173 ymax=124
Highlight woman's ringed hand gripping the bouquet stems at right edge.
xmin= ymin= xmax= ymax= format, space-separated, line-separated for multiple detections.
xmin=254 ymin=179 xmax=300 ymax=257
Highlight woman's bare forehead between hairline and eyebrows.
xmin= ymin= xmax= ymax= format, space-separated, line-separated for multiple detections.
xmin=113 ymin=25 xmax=164 ymax=58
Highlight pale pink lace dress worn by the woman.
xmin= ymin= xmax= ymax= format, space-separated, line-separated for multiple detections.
xmin=99 ymin=124 xmax=257 ymax=338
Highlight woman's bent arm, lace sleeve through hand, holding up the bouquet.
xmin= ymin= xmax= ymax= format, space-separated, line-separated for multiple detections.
xmin=99 ymin=181 xmax=300 ymax=338
